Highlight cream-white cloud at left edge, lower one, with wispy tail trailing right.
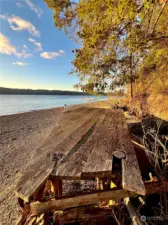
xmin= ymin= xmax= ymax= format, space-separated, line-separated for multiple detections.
xmin=0 ymin=33 xmax=33 ymax=58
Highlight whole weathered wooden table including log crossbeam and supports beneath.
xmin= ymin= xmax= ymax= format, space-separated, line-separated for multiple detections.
xmin=16 ymin=107 xmax=164 ymax=224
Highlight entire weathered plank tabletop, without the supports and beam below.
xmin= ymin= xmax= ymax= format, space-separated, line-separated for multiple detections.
xmin=16 ymin=107 xmax=146 ymax=202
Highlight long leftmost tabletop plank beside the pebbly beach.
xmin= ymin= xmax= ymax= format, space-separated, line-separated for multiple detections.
xmin=17 ymin=108 xmax=101 ymax=202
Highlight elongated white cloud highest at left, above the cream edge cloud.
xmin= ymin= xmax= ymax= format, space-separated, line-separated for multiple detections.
xmin=0 ymin=15 xmax=40 ymax=37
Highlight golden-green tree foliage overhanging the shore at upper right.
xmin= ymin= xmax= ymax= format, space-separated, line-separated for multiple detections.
xmin=44 ymin=0 xmax=168 ymax=118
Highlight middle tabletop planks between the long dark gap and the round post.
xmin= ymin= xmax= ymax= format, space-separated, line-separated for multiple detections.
xmin=55 ymin=109 xmax=122 ymax=178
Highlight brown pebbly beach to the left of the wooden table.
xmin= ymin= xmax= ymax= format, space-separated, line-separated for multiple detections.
xmin=0 ymin=108 xmax=63 ymax=225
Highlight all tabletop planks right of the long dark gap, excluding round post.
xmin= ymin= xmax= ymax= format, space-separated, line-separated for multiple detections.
xmin=55 ymin=110 xmax=145 ymax=197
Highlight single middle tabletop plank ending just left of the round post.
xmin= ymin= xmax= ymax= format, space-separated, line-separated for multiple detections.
xmin=82 ymin=110 xmax=122 ymax=175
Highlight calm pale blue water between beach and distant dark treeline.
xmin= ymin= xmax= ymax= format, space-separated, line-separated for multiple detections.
xmin=0 ymin=95 xmax=106 ymax=115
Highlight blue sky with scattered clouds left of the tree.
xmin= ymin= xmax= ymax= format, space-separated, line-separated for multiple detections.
xmin=0 ymin=0 xmax=78 ymax=90
